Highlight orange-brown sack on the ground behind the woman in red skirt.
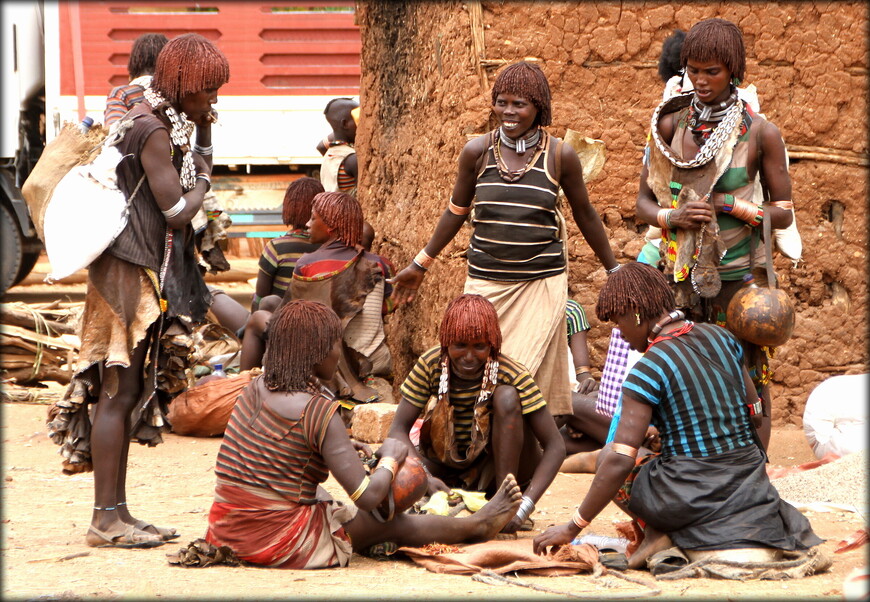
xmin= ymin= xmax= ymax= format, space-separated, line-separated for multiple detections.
xmin=167 ymin=370 xmax=260 ymax=437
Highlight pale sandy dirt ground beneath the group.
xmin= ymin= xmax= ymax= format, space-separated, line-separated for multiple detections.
xmin=0 ymin=396 xmax=867 ymax=600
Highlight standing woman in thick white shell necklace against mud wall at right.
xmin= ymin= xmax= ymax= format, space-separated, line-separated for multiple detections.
xmin=637 ymin=19 xmax=793 ymax=446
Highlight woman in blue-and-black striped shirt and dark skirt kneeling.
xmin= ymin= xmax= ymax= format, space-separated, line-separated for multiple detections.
xmin=534 ymin=262 xmax=823 ymax=572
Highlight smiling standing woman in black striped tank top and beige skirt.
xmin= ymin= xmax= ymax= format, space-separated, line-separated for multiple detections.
xmin=393 ymin=62 xmax=618 ymax=416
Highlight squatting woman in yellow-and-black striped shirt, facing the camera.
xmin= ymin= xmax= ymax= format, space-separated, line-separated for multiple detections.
xmin=390 ymin=294 xmax=565 ymax=533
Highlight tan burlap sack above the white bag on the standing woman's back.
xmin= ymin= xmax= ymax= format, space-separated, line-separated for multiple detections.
xmin=21 ymin=121 xmax=107 ymax=242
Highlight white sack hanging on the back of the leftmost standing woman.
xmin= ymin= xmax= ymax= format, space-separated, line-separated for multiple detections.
xmin=45 ymin=145 xmax=127 ymax=283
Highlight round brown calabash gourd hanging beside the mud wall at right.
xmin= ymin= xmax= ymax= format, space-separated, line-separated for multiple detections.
xmin=725 ymin=277 xmax=794 ymax=347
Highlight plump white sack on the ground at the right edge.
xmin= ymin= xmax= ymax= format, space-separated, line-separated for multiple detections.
xmin=804 ymin=374 xmax=870 ymax=458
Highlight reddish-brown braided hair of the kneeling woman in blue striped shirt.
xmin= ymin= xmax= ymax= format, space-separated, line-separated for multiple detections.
xmin=595 ymin=261 xmax=677 ymax=322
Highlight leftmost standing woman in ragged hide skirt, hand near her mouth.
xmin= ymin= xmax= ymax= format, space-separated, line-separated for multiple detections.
xmin=48 ymin=34 xmax=230 ymax=548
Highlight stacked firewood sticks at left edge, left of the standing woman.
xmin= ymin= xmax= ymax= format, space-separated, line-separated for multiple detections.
xmin=0 ymin=301 xmax=84 ymax=385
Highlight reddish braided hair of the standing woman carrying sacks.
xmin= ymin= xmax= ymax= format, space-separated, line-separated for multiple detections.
xmin=151 ymin=33 xmax=230 ymax=105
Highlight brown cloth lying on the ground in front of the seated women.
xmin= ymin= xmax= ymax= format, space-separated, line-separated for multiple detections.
xmin=398 ymin=539 xmax=598 ymax=577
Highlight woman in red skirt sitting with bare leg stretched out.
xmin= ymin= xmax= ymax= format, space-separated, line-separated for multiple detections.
xmin=206 ymin=300 xmax=521 ymax=569
